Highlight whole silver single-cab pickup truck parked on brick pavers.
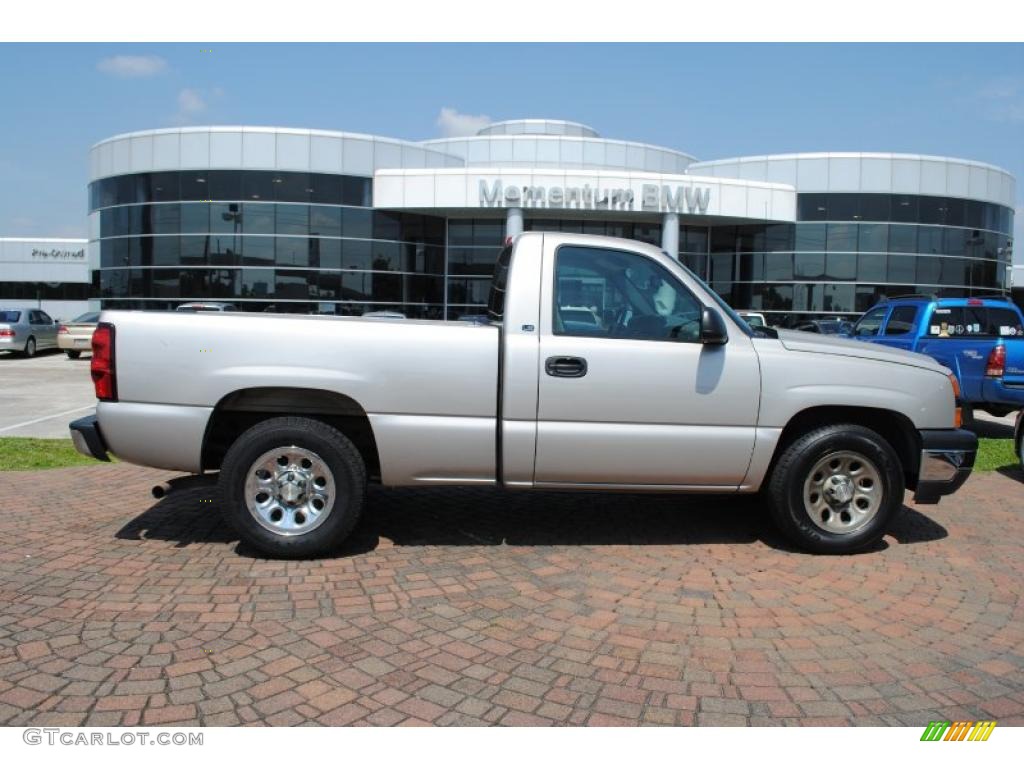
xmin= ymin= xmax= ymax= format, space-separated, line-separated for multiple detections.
xmin=71 ymin=232 xmax=977 ymax=556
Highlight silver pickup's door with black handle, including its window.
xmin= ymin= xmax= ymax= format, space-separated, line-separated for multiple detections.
xmin=535 ymin=243 xmax=761 ymax=488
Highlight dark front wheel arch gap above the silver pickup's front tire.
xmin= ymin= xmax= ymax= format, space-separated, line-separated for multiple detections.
xmin=765 ymin=406 xmax=921 ymax=490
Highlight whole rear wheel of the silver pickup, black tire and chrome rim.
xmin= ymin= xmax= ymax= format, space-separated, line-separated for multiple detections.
xmin=219 ymin=417 xmax=367 ymax=557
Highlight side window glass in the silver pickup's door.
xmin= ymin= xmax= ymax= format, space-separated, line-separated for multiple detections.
xmin=552 ymin=246 xmax=702 ymax=342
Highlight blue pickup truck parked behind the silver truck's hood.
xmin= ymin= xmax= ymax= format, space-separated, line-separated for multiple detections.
xmin=851 ymin=296 xmax=1024 ymax=416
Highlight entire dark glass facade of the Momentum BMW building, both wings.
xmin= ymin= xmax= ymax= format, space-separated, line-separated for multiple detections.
xmin=89 ymin=170 xmax=1013 ymax=326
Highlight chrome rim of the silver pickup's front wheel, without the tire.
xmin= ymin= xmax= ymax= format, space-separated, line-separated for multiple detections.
xmin=804 ymin=451 xmax=884 ymax=534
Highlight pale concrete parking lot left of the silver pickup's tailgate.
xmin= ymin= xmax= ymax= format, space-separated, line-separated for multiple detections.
xmin=0 ymin=350 xmax=96 ymax=437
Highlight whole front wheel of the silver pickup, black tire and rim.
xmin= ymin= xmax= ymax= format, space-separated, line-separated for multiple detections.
xmin=768 ymin=424 xmax=905 ymax=554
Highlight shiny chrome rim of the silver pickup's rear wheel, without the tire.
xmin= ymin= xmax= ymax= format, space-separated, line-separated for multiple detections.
xmin=245 ymin=445 xmax=335 ymax=536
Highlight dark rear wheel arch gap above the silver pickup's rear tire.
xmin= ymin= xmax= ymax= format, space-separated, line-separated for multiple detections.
xmin=201 ymin=387 xmax=381 ymax=479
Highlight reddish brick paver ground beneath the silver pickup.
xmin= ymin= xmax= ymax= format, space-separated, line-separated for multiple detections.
xmin=0 ymin=465 xmax=1024 ymax=726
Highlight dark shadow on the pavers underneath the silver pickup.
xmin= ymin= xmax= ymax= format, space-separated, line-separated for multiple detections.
xmin=117 ymin=487 xmax=947 ymax=557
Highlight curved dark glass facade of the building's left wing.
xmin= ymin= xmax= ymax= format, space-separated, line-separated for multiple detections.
xmin=89 ymin=171 xmax=445 ymax=318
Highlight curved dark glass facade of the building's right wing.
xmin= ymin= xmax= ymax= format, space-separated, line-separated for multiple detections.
xmin=700 ymin=194 xmax=1013 ymax=325
